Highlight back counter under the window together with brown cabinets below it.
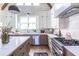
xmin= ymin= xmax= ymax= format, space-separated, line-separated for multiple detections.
xmin=9 ymin=32 xmax=48 ymax=45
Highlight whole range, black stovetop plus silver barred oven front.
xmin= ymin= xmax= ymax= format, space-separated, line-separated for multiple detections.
xmin=52 ymin=37 xmax=79 ymax=56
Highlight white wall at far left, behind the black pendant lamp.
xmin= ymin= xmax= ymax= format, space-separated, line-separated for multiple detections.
xmin=0 ymin=4 xmax=15 ymax=28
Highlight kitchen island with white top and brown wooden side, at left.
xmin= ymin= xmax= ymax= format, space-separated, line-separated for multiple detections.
xmin=0 ymin=36 xmax=30 ymax=56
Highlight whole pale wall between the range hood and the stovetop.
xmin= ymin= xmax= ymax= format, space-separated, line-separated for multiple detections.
xmin=59 ymin=14 xmax=79 ymax=40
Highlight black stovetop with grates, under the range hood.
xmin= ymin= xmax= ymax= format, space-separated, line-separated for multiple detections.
xmin=55 ymin=38 xmax=79 ymax=46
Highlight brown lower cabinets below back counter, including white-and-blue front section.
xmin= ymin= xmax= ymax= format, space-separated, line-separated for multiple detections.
xmin=32 ymin=34 xmax=48 ymax=45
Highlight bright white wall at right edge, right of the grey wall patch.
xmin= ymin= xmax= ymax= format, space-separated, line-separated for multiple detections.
xmin=69 ymin=14 xmax=79 ymax=40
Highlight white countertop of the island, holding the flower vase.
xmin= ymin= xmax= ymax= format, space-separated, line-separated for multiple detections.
xmin=0 ymin=36 xmax=30 ymax=56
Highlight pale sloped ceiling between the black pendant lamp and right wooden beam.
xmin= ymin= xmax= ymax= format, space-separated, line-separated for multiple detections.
xmin=18 ymin=3 xmax=52 ymax=15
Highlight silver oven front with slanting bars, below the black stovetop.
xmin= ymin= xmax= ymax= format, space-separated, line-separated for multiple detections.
xmin=52 ymin=38 xmax=63 ymax=56
